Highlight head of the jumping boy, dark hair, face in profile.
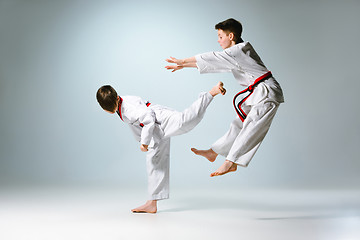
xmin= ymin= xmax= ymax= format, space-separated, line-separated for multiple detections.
xmin=215 ymin=18 xmax=243 ymax=49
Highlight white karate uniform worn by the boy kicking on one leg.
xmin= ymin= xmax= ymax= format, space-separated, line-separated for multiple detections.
xmin=118 ymin=92 xmax=213 ymax=200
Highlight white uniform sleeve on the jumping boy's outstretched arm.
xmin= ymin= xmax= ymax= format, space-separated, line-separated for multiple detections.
xmin=195 ymin=47 xmax=239 ymax=73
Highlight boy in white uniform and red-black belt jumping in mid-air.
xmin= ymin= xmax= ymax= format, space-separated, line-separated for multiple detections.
xmin=165 ymin=18 xmax=284 ymax=177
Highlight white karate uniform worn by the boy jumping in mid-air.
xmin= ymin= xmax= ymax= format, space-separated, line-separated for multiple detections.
xmin=195 ymin=42 xmax=284 ymax=167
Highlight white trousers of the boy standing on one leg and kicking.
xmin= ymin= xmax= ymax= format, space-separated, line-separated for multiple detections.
xmin=146 ymin=92 xmax=213 ymax=200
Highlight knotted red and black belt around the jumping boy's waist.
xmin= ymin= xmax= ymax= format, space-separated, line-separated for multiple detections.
xmin=233 ymin=71 xmax=272 ymax=122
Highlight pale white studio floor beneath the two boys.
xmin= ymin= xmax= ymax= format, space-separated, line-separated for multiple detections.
xmin=0 ymin=188 xmax=360 ymax=240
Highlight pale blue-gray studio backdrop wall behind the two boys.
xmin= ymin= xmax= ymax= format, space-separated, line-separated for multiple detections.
xmin=0 ymin=0 xmax=360 ymax=190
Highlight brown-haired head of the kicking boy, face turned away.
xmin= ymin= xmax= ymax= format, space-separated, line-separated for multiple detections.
xmin=96 ymin=85 xmax=119 ymax=113
